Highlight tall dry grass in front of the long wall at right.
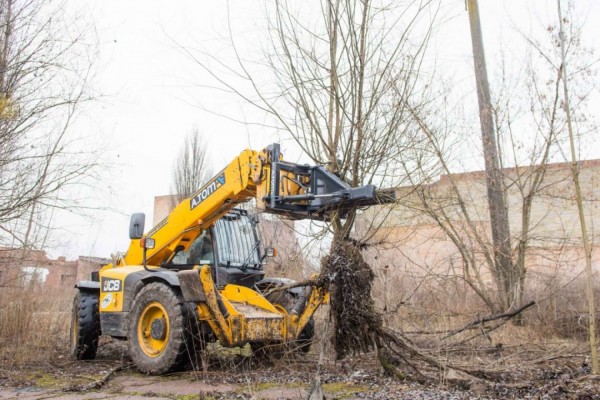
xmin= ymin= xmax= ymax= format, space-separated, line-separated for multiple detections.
xmin=373 ymin=262 xmax=600 ymax=343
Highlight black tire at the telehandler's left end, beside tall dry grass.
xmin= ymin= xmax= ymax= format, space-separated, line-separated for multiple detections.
xmin=70 ymin=290 xmax=100 ymax=360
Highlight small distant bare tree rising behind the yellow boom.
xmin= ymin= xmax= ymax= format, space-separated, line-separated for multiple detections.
xmin=171 ymin=127 xmax=213 ymax=206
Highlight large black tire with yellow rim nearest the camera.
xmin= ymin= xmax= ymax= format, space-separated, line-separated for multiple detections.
xmin=128 ymin=282 xmax=189 ymax=375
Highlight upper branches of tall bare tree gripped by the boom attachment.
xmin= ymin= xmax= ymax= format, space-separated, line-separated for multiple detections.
xmin=183 ymin=0 xmax=438 ymax=238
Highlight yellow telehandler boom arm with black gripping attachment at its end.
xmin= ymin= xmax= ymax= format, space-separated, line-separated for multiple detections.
xmin=119 ymin=144 xmax=393 ymax=265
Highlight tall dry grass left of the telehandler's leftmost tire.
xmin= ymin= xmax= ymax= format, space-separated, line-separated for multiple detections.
xmin=0 ymin=285 xmax=73 ymax=368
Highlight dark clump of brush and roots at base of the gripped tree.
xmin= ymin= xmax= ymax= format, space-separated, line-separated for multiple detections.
xmin=308 ymin=239 xmax=534 ymax=400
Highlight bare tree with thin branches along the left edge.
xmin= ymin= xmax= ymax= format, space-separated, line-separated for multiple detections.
xmin=0 ymin=0 xmax=100 ymax=253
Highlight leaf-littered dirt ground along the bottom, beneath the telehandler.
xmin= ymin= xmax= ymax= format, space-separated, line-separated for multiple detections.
xmin=0 ymin=338 xmax=600 ymax=400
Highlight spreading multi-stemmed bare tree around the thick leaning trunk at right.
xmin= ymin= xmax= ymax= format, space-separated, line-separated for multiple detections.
xmin=386 ymin=3 xmax=595 ymax=312
